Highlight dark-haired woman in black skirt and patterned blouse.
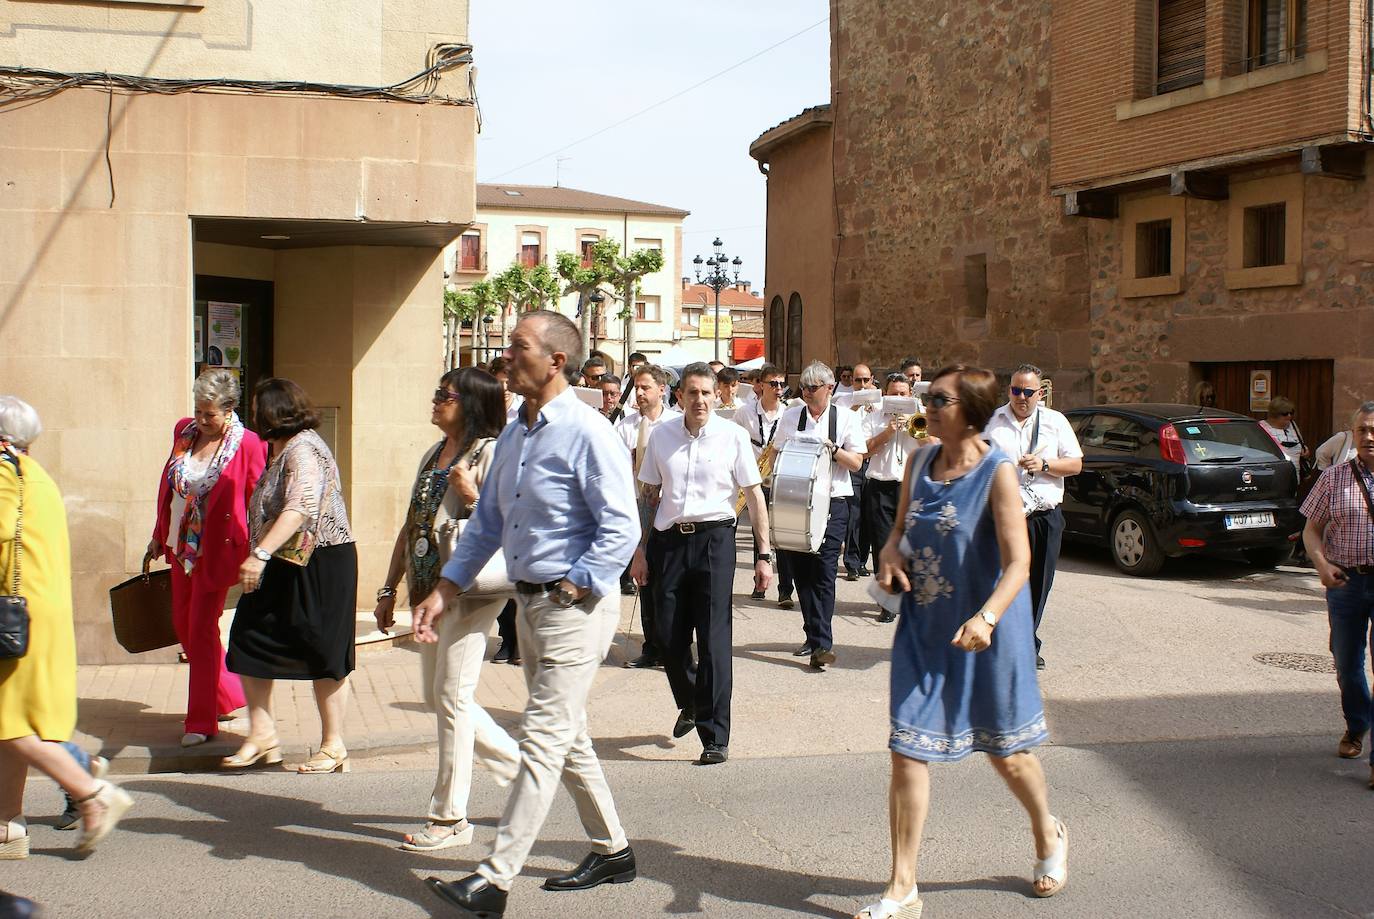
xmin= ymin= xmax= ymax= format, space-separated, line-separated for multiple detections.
xmin=223 ymin=378 xmax=357 ymax=775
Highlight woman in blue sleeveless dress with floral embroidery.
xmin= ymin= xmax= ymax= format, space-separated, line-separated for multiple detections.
xmin=856 ymin=364 xmax=1069 ymax=919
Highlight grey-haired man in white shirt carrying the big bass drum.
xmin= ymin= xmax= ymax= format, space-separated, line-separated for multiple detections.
xmin=774 ymin=361 xmax=864 ymax=670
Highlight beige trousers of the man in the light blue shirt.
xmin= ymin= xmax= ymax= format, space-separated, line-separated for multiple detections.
xmin=477 ymin=595 xmax=629 ymax=890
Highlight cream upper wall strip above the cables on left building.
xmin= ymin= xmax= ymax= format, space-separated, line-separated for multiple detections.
xmin=0 ymin=0 xmax=469 ymax=95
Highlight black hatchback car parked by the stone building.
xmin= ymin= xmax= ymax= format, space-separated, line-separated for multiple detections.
xmin=1063 ymin=404 xmax=1303 ymax=576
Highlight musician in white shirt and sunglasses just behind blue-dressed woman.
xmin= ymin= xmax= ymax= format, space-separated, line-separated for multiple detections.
xmin=984 ymin=364 xmax=1083 ymax=670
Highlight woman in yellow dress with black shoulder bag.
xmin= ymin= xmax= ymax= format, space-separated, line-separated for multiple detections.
xmin=0 ymin=396 xmax=133 ymax=860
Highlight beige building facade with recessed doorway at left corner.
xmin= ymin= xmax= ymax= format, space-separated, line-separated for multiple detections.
xmin=0 ymin=0 xmax=475 ymax=662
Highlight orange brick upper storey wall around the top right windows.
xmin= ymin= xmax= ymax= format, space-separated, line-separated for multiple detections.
xmin=1050 ymin=0 xmax=1363 ymax=187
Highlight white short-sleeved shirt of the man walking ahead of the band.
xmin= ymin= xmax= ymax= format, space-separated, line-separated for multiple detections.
xmin=639 ymin=413 xmax=763 ymax=530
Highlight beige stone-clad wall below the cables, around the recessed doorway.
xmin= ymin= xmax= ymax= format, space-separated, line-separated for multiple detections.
xmin=0 ymin=84 xmax=475 ymax=662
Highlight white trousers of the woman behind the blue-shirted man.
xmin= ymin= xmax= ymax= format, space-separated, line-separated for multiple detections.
xmin=420 ymin=599 xmax=519 ymax=823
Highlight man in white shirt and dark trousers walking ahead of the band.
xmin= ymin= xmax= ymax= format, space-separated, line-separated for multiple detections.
xmin=631 ymin=364 xmax=772 ymax=765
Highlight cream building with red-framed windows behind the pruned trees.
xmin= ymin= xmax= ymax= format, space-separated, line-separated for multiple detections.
xmin=444 ymin=184 xmax=690 ymax=367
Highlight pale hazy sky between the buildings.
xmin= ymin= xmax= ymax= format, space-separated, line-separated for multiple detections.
xmin=470 ymin=0 xmax=830 ymax=291
